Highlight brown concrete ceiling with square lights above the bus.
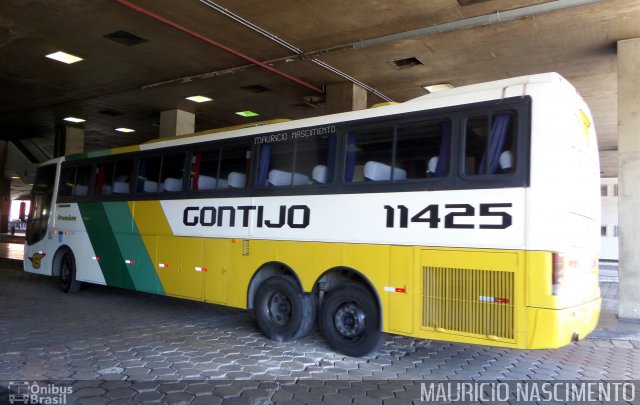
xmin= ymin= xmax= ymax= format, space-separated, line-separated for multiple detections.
xmin=0 ymin=0 xmax=640 ymax=189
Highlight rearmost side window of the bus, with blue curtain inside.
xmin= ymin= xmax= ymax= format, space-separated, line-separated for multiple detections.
xmin=464 ymin=112 xmax=516 ymax=176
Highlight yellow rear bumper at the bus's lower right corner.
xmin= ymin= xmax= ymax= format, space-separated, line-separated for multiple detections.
xmin=526 ymin=297 xmax=602 ymax=349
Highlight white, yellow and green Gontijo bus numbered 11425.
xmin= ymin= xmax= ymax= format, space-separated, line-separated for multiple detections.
xmin=24 ymin=73 xmax=601 ymax=356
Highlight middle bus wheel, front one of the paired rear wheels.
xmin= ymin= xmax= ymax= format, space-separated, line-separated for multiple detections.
xmin=253 ymin=276 xmax=316 ymax=342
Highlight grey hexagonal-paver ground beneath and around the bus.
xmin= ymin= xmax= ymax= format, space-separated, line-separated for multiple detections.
xmin=0 ymin=262 xmax=640 ymax=404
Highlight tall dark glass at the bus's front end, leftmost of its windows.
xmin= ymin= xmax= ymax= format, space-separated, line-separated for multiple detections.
xmin=26 ymin=165 xmax=56 ymax=245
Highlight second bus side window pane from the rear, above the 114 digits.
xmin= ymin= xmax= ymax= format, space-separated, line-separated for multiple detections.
xmin=395 ymin=120 xmax=451 ymax=179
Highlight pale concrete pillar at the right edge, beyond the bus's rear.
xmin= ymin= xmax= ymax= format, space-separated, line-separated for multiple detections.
xmin=618 ymin=38 xmax=640 ymax=319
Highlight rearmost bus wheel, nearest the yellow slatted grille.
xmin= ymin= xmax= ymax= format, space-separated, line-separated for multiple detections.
xmin=320 ymin=284 xmax=384 ymax=357
